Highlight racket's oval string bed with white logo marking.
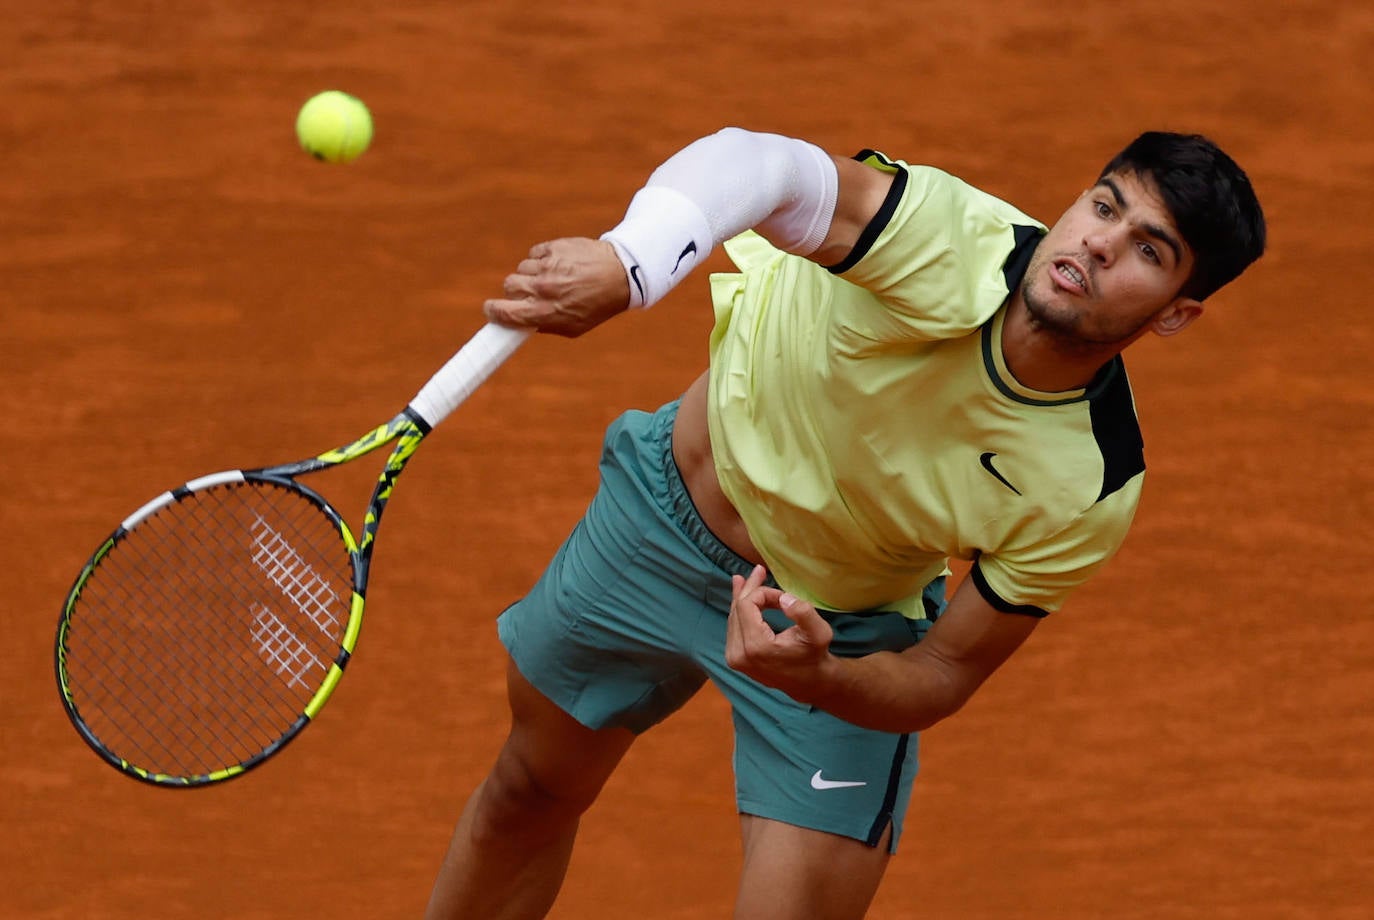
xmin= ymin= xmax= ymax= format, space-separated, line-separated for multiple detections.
xmin=65 ymin=481 xmax=352 ymax=776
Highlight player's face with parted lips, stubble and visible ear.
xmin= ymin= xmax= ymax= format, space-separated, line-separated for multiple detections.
xmin=1022 ymin=173 xmax=1202 ymax=345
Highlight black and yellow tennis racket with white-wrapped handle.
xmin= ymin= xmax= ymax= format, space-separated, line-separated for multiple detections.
xmin=56 ymin=324 xmax=529 ymax=787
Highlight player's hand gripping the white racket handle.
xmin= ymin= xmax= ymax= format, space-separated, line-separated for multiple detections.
xmin=482 ymin=238 xmax=629 ymax=338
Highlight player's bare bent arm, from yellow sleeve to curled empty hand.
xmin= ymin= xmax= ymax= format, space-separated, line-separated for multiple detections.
xmin=725 ymin=567 xmax=1040 ymax=732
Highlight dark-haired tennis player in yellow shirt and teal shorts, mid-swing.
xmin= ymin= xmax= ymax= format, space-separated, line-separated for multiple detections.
xmin=429 ymin=128 xmax=1265 ymax=920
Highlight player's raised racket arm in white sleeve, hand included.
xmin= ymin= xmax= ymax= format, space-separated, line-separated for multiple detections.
xmin=484 ymin=128 xmax=892 ymax=335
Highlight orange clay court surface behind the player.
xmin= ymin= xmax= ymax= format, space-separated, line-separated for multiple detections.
xmin=0 ymin=0 xmax=1374 ymax=920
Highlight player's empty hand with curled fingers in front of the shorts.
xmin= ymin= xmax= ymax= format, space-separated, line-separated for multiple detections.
xmin=725 ymin=566 xmax=834 ymax=703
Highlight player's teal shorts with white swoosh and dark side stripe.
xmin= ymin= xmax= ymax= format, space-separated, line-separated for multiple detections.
xmin=497 ymin=402 xmax=944 ymax=851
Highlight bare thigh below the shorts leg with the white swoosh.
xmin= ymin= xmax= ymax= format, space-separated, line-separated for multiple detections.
xmin=735 ymin=814 xmax=890 ymax=920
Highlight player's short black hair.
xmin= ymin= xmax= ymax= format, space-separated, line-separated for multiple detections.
xmin=1098 ymin=130 xmax=1265 ymax=301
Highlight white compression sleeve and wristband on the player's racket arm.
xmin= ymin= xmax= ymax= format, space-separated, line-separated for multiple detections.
xmin=602 ymin=128 xmax=840 ymax=308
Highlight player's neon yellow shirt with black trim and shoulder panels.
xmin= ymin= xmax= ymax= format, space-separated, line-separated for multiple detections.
xmin=708 ymin=151 xmax=1145 ymax=618
